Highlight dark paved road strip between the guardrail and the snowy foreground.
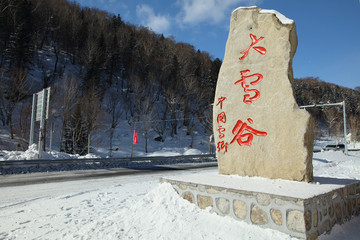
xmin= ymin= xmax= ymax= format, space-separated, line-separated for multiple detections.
xmin=0 ymin=162 xmax=217 ymax=187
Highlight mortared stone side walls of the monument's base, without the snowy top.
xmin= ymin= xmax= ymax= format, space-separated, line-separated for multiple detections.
xmin=161 ymin=178 xmax=360 ymax=239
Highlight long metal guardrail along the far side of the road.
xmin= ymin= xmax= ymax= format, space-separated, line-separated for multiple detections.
xmin=0 ymin=154 xmax=216 ymax=175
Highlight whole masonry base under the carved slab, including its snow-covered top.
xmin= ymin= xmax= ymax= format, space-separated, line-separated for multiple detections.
xmin=160 ymin=173 xmax=360 ymax=239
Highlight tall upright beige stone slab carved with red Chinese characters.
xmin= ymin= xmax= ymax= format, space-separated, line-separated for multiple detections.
xmin=213 ymin=7 xmax=313 ymax=182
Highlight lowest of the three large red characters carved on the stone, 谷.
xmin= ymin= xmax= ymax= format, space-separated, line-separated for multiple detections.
xmin=230 ymin=118 xmax=267 ymax=146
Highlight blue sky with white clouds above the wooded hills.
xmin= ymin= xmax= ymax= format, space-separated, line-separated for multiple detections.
xmin=76 ymin=0 xmax=360 ymax=88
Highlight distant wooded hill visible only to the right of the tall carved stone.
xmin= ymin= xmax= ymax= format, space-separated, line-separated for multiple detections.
xmin=293 ymin=78 xmax=360 ymax=141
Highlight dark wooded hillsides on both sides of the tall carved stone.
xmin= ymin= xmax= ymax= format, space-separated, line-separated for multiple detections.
xmin=0 ymin=0 xmax=360 ymax=154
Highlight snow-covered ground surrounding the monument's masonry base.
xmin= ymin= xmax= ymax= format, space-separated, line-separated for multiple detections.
xmin=0 ymin=151 xmax=360 ymax=239
